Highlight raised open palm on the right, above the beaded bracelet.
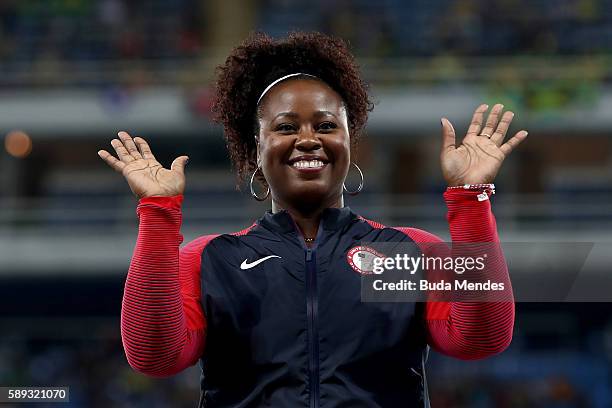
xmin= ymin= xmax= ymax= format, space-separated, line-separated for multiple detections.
xmin=440 ymin=104 xmax=527 ymax=186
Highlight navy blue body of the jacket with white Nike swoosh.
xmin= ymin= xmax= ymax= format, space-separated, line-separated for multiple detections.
xmin=199 ymin=207 xmax=429 ymax=408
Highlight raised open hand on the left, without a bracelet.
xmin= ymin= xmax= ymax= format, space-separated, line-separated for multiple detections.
xmin=98 ymin=132 xmax=189 ymax=199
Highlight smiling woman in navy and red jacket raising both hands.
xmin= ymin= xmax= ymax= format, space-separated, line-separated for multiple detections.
xmin=99 ymin=33 xmax=527 ymax=407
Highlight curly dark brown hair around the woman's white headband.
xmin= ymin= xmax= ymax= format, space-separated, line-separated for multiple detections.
xmin=212 ymin=32 xmax=373 ymax=188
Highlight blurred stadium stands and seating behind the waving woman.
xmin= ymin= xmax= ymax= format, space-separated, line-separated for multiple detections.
xmin=0 ymin=0 xmax=612 ymax=408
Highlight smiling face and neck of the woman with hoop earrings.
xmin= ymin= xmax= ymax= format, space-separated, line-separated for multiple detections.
xmin=257 ymin=76 xmax=350 ymax=222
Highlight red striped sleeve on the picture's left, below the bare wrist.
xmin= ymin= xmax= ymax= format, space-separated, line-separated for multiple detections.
xmin=121 ymin=195 xmax=214 ymax=377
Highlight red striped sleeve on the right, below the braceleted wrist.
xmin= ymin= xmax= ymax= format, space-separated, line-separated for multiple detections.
xmin=398 ymin=190 xmax=514 ymax=360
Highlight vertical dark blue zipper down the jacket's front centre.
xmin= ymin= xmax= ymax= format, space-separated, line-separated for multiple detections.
xmin=306 ymin=248 xmax=319 ymax=408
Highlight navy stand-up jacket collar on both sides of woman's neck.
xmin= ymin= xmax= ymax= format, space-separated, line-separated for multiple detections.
xmin=257 ymin=206 xmax=358 ymax=233
